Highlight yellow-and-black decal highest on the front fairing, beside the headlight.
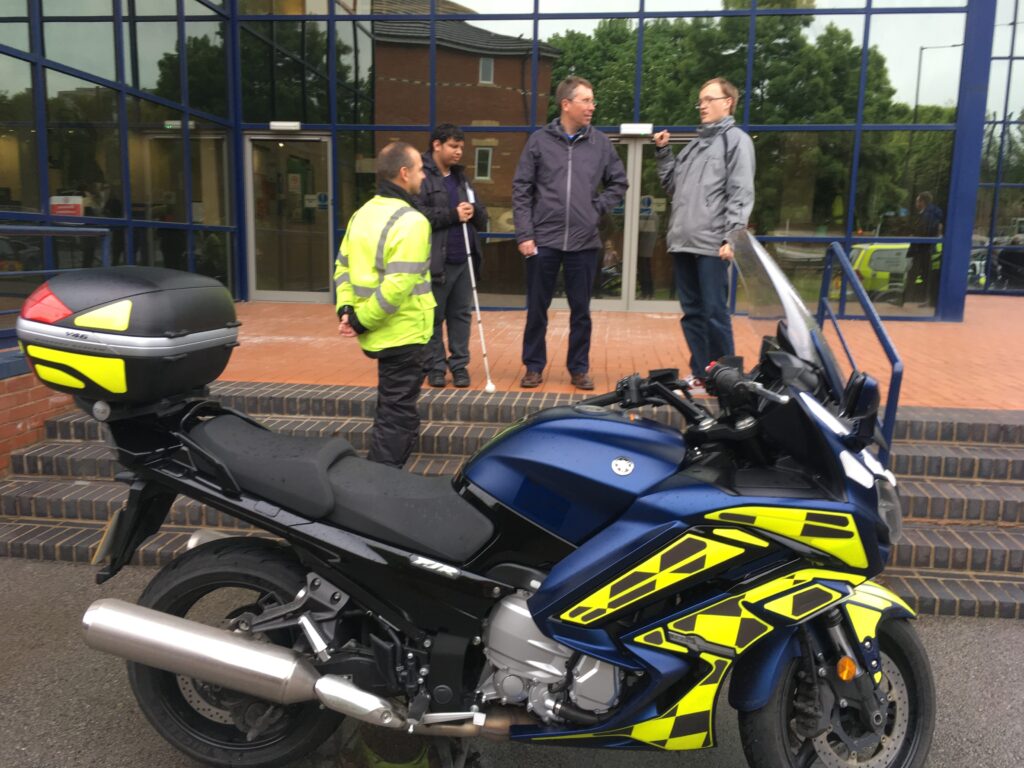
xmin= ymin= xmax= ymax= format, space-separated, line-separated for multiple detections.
xmin=706 ymin=506 xmax=867 ymax=568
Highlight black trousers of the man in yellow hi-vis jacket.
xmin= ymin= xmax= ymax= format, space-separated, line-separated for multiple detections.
xmin=367 ymin=344 xmax=427 ymax=468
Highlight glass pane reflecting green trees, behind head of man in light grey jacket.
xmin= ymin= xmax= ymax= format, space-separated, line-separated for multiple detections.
xmin=640 ymin=16 xmax=750 ymax=125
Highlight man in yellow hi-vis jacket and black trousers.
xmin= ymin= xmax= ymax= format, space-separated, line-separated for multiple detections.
xmin=334 ymin=141 xmax=435 ymax=467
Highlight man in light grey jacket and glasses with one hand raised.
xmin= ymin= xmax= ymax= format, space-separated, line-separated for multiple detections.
xmin=654 ymin=78 xmax=755 ymax=391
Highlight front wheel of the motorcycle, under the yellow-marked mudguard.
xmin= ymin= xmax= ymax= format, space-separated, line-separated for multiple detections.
xmin=739 ymin=620 xmax=935 ymax=768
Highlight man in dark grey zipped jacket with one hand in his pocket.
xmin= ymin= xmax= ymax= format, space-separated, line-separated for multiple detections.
xmin=512 ymin=76 xmax=628 ymax=389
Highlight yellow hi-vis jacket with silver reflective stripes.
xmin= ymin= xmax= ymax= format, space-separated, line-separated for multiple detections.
xmin=334 ymin=195 xmax=435 ymax=352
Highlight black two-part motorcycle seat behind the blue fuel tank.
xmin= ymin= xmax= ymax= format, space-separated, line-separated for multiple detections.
xmin=188 ymin=415 xmax=494 ymax=563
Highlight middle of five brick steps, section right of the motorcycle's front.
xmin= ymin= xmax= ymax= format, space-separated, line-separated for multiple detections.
xmin=898 ymin=478 xmax=1024 ymax=525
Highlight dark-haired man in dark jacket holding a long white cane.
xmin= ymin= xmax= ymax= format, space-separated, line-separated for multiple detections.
xmin=416 ymin=128 xmax=487 ymax=387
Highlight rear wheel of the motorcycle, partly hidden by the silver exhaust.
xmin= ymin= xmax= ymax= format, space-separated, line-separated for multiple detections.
xmin=128 ymin=539 xmax=343 ymax=768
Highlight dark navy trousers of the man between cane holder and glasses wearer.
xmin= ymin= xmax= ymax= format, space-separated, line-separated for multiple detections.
xmin=522 ymin=247 xmax=598 ymax=374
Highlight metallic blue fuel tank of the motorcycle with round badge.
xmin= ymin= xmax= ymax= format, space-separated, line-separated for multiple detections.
xmin=463 ymin=404 xmax=686 ymax=545
